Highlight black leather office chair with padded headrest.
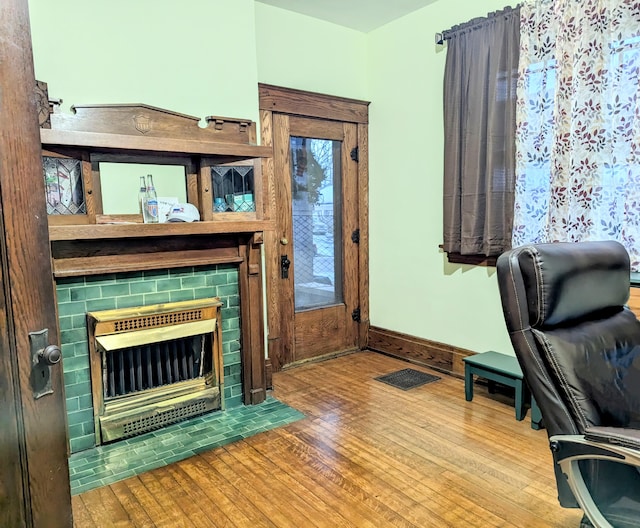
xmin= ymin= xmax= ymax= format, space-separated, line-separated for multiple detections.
xmin=497 ymin=241 xmax=640 ymax=528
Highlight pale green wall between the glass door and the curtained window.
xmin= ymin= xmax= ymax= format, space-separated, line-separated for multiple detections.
xmin=367 ymin=0 xmax=513 ymax=353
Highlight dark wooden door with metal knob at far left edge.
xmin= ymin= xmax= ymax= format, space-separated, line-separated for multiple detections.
xmin=0 ymin=0 xmax=72 ymax=528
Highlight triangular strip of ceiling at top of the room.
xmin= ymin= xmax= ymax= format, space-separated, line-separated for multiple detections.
xmin=257 ymin=0 xmax=437 ymax=33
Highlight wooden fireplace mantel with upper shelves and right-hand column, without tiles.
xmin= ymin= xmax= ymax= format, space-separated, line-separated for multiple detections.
xmin=41 ymin=98 xmax=273 ymax=404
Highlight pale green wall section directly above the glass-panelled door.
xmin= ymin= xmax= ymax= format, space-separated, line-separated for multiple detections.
xmin=255 ymin=2 xmax=367 ymax=99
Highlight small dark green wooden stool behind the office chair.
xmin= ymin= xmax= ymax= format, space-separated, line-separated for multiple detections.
xmin=463 ymin=351 xmax=542 ymax=429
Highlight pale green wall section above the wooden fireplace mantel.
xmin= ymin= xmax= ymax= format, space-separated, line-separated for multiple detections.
xmin=29 ymin=0 xmax=258 ymax=120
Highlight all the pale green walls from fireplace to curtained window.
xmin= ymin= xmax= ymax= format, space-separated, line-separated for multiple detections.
xmin=30 ymin=0 xmax=511 ymax=352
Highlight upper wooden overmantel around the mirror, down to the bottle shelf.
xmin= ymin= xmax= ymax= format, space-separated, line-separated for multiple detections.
xmin=40 ymin=104 xmax=273 ymax=240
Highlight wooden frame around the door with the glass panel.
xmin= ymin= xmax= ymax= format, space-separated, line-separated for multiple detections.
xmin=258 ymin=84 xmax=369 ymax=380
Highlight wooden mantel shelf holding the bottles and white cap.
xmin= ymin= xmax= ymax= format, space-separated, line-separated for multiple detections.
xmin=49 ymin=220 xmax=274 ymax=241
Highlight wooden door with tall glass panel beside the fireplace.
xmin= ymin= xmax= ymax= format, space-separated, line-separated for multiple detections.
xmin=274 ymin=114 xmax=358 ymax=362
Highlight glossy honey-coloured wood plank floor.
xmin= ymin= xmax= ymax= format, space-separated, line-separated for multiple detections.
xmin=73 ymin=352 xmax=582 ymax=528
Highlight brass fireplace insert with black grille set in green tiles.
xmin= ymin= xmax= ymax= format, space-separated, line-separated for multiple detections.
xmin=87 ymin=298 xmax=223 ymax=444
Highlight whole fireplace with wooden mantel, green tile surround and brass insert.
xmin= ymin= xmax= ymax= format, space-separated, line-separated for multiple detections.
xmin=41 ymin=98 xmax=273 ymax=454
